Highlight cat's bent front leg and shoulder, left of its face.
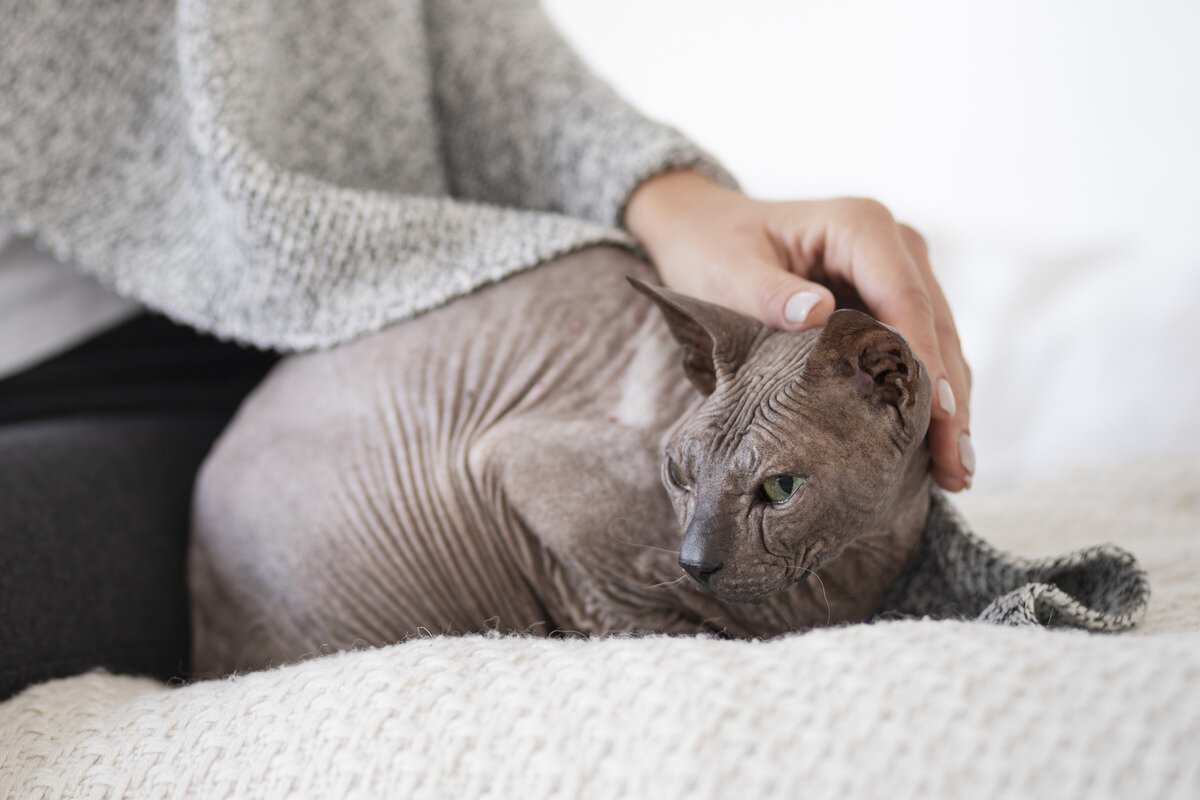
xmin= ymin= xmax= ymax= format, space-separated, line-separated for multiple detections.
xmin=469 ymin=414 xmax=709 ymax=633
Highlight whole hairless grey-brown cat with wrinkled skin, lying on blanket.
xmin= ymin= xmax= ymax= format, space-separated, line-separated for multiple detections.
xmin=190 ymin=248 xmax=930 ymax=674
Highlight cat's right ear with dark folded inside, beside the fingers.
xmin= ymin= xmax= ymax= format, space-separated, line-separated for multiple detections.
xmin=804 ymin=308 xmax=922 ymax=419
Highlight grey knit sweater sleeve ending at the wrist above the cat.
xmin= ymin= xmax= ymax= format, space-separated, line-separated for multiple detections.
xmin=425 ymin=0 xmax=734 ymax=225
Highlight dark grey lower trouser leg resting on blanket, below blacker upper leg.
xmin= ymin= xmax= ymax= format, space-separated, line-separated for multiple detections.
xmin=0 ymin=416 xmax=224 ymax=698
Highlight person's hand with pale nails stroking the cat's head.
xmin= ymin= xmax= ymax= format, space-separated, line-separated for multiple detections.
xmin=625 ymin=170 xmax=976 ymax=492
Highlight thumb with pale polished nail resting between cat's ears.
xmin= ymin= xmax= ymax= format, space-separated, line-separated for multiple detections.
xmin=719 ymin=259 xmax=835 ymax=331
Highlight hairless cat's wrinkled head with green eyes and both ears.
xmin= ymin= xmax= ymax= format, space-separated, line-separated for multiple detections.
xmin=630 ymin=278 xmax=931 ymax=602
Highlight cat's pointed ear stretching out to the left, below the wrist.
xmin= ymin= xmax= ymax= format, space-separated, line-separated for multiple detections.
xmin=626 ymin=276 xmax=763 ymax=395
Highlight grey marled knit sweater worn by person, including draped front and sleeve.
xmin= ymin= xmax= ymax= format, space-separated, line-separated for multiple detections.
xmin=0 ymin=0 xmax=732 ymax=350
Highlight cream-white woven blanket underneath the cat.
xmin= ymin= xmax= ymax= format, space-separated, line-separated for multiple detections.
xmin=0 ymin=461 xmax=1200 ymax=800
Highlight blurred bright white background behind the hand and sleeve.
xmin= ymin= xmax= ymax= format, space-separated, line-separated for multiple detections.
xmin=545 ymin=0 xmax=1200 ymax=486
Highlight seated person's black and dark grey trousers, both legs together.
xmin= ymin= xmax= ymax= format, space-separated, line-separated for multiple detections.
xmin=0 ymin=315 xmax=277 ymax=699
